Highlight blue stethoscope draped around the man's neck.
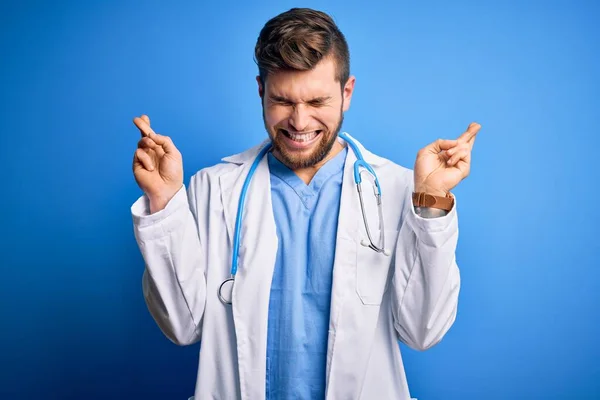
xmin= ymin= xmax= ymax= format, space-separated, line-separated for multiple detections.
xmin=218 ymin=132 xmax=389 ymax=304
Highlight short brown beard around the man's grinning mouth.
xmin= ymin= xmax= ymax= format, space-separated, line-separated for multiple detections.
xmin=263 ymin=104 xmax=344 ymax=170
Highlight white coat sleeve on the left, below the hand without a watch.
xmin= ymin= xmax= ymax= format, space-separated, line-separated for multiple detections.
xmin=131 ymin=173 xmax=208 ymax=345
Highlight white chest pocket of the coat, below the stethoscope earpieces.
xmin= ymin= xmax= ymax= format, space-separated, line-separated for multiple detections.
xmin=356 ymin=230 xmax=398 ymax=306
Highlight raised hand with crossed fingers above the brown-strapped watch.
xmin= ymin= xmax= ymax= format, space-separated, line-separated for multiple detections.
xmin=414 ymin=122 xmax=481 ymax=196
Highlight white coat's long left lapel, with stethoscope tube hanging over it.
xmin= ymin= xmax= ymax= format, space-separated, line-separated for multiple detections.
xmin=220 ymin=143 xmax=278 ymax=399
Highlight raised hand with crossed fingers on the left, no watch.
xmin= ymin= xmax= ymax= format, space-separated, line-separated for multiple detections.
xmin=133 ymin=115 xmax=183 ymax=213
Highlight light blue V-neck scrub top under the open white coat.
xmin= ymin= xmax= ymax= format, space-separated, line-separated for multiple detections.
xmin=266 ymin=148 xmax=348 ymax=400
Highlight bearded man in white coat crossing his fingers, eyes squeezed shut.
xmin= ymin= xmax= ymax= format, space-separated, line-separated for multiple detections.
xmin=132 ymin=9 xmax=479 ymax=399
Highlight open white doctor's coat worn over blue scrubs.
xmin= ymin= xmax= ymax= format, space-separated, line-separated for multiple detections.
xmin=131 ymin=137 xmax=460 ymax=400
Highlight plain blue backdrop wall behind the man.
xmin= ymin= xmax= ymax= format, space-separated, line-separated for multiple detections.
xmin=0 ymin=0 xmax=600 ymax=400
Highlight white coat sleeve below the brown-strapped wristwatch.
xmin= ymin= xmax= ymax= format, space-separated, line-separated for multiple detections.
xmin=392 ymin=177 xmax=460 ymax=350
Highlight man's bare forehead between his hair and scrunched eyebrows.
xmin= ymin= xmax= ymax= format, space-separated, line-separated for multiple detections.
xmin=265 ymin=58 xmax=340 ymax=100
